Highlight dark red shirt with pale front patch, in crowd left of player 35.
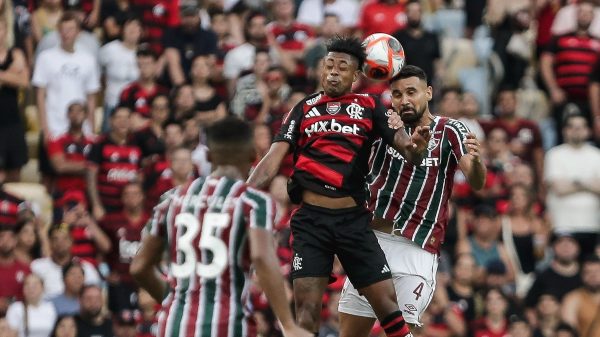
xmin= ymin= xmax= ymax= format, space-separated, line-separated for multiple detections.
xmin=99 ymin=212 xmax=150 ymax=285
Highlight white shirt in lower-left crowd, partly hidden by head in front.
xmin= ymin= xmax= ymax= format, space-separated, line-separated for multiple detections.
xmin=30 ymin=257 xmax=101 ymax=299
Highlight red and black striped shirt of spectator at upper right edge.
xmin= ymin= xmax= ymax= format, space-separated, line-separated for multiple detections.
xmin=548 ymin=33 xmax=600 ymax=100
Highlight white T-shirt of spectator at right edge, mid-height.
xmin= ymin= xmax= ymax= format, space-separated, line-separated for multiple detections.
xmin=544 ymin=144 xmax=600 ymax=233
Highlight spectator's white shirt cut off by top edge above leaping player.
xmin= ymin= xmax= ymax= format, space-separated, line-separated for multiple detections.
xmin=297 ymin=0 xmax=360 ymax=32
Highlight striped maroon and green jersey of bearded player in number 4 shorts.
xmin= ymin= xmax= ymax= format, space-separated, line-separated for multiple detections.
xmin=367 ymin=117 xmax=469 ymax=254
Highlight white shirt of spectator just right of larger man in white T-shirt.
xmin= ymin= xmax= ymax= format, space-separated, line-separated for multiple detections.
xmin=98 ymin=40 xmax=140 ymax=107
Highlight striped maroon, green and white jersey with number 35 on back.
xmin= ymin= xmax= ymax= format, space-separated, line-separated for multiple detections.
xmin=147 ymin=177 xmax=276 ymax=337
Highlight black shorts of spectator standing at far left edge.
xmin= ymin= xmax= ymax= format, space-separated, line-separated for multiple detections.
xmin=0 ymin=124 xmax=29 ymax=170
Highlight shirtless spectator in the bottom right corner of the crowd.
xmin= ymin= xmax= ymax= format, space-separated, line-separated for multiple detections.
xmin=561 ymin=255 xmax=600 ymax=337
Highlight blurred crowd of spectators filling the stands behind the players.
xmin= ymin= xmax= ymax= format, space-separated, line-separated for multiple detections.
xmin=0 ymin=0 xmax=600 ymax=337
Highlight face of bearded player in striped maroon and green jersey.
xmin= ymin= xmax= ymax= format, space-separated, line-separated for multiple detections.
xmin=390 ymin=76 xmax=431 ymax=125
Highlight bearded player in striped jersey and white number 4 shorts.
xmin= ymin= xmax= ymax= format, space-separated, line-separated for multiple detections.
xmin=339 ymin=66 xmax=486 ymax=337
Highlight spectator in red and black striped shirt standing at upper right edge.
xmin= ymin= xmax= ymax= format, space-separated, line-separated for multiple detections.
xmin=540 ymin=1 xmax=600 ymax=143
